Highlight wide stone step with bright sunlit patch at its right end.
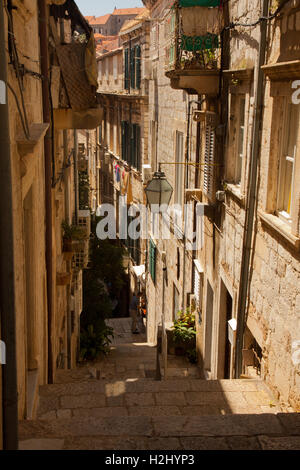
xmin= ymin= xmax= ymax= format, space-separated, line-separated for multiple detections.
xmin=38 ymin=379 xmax=280 ymax=419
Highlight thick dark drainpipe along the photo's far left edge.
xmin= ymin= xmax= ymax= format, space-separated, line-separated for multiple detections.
xmin=0 ymin=0 xmax=18 ymax=450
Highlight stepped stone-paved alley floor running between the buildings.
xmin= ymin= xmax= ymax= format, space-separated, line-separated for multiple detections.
xmin=20 ymin=319 xmax=300 ymax=450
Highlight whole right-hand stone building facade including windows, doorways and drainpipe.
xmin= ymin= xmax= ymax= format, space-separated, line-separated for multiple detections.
xmin=144 ymin=0 xmax=300 ymax=410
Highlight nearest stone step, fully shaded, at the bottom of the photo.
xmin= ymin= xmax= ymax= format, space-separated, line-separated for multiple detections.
xmin=19 ymin=413 xmax=300 ymax=449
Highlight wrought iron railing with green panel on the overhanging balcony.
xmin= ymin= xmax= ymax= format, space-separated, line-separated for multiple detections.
xmin=165 ymin=0 xmax=222 ymax=72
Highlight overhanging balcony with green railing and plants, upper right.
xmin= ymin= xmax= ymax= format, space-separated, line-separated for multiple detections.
xmin=165 ymin=0 xmax=223 ymax=95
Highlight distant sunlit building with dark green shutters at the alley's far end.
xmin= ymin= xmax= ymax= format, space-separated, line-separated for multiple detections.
xmin=97 ymin=9 xmax=149 ymax=302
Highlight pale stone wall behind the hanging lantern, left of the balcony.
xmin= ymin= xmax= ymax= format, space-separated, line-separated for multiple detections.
xmin=147 ymin=1 xmax=198 ymax=343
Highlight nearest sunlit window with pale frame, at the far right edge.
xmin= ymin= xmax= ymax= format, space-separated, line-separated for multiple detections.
xmin=277 ymin=103 xmax=300 ymax=223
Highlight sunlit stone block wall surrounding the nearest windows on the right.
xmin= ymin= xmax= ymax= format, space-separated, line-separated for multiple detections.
xmin=199 ymin=2 xmax=300 ymax=410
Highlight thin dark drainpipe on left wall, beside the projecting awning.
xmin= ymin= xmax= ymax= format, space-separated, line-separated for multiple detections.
xmin=38 ymin=0 xmax=54 ymax=383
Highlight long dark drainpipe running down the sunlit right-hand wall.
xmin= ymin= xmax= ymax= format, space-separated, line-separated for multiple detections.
xmin=235 ymin=0 xmax=269 ymax=379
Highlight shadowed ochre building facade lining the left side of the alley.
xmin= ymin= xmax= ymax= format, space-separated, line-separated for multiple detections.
xmin=0 ymin=0 xmax=102 ymax=447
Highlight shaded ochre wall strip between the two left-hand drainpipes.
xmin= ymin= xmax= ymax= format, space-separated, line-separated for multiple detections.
xmin=5 ymin=1 xmax=47 ymax=418
